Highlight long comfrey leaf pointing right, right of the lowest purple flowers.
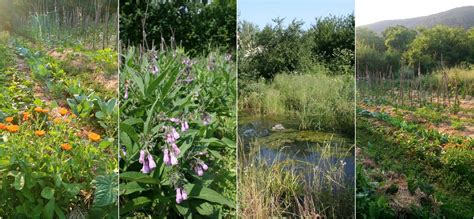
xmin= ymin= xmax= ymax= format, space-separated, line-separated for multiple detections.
xmin=184 ymin=184 xmax=235 ymax=208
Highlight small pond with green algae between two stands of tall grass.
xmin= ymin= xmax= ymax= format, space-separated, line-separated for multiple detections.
xmin=238 ymin=116 xmax=355 ymax=183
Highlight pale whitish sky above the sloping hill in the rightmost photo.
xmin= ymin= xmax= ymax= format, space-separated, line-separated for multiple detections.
xmin=355 ymin=0 xmax=474 ymax=26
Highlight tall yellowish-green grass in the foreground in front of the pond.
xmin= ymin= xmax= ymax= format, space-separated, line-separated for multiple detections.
xmin=238 ymin=138 xmax=354 ymax=218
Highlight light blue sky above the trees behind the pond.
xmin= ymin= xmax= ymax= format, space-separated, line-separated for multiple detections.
xmin=237 ymin=0 xmax=354 ymax=28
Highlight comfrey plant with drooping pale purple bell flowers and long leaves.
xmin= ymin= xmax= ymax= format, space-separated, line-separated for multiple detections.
xmin=120 ymin=46 xmax=235 ymax=218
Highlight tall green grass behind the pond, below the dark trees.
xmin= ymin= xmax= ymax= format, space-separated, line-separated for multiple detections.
xmin=239 ymin=74 xmax=354 ymax=133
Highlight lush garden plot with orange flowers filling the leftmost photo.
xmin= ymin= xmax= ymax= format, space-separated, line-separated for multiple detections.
xmin=0 ymin=1 xmax=118 ymax=218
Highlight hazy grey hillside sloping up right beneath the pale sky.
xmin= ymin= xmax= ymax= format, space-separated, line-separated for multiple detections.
xmin=361 ymin=6 xmax=474 ymax=33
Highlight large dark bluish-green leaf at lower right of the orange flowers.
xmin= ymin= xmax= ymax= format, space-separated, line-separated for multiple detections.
xmin=94 ymin=174 xmax=118 ymax=207
